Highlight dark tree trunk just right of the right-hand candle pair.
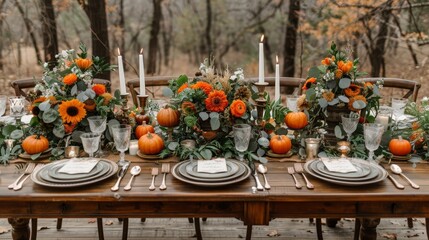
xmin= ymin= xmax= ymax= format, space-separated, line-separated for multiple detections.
xmin=283 ymin=0 xmax=301 ymax=77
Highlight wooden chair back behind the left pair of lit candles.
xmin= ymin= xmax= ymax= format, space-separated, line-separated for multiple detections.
xmin=127 ymin=76 xmax=176 ymax=106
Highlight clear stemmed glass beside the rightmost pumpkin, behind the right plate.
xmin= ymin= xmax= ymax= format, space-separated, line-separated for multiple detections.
xmin=363 ymin=123 xmax=384 ymax=162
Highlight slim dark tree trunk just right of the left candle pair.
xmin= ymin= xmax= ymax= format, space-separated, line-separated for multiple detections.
xmin=146 ymin=0 xmax=162 ymax=74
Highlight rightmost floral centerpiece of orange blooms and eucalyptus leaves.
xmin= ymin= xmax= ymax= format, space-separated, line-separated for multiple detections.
xmin=298 ymin=43 xmax=382 ymax=143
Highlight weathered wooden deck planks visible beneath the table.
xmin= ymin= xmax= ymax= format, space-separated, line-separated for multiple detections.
xmin=0 ymin=218 xmax=427 ymax=240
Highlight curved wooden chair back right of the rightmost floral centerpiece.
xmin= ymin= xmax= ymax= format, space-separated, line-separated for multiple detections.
xmin=358 ymin=78 xmax=422 ymax=102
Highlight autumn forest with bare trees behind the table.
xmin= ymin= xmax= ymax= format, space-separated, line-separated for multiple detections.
xmin=0 ymin=0 xmax=429 ymax=98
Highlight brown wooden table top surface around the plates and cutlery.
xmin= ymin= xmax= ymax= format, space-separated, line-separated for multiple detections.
xmin=0 ymin=155 xmax=429 ymax=202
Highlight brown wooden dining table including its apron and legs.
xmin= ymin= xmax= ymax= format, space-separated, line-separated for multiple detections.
xmin=0 ymin=154 xmax=429 ymax=240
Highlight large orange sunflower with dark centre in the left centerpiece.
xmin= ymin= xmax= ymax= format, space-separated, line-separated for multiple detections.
xmin=58 ymin=99 xmax=86 ymax=124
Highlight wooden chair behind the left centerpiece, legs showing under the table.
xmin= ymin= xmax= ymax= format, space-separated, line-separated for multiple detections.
xmin=10 ymin=78 xmax=111 ymax=240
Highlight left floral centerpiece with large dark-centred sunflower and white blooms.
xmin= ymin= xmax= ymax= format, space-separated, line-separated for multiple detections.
xmin=27 ymin=44 xmax=121 ymax=158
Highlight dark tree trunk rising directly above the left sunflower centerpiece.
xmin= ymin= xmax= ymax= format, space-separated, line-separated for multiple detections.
xmin=39 ymin=0 xmax=58 ymax=69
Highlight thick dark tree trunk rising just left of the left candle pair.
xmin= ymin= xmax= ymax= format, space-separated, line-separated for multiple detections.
xmin=78 ymin=0 xmax=110 ymax=80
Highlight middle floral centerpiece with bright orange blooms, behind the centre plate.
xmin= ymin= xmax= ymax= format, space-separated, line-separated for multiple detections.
xmin=158 ymin=60 xmax=285 ymax=162
